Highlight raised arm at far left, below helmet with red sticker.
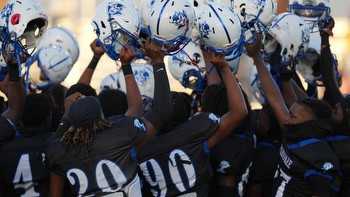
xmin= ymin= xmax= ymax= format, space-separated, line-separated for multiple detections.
xmin=2 ymin=54 xmax=26 ymax=125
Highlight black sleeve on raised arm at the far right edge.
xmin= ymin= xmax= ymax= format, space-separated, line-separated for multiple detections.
xmin=320 ymin=34 xmax=343 ymax=107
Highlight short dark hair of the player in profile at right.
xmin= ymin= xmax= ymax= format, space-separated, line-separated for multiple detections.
xmin=296 ymin=97 xmax=332 ymax=120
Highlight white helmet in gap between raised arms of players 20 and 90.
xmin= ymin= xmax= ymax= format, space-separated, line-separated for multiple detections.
xmin=168 ymin=40 xmax=206 ymax=92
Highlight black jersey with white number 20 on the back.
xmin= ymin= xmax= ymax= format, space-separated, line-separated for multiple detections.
xmin=47 ymin=116 xmax=146 ymax=196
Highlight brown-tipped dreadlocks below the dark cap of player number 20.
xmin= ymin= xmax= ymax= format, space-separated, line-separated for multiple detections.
xmin=61 ymin=119 xmax=113 ymax=155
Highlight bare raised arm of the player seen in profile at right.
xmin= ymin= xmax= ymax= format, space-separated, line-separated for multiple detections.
xmin=245 ymin=35 xmax=289 ymax=127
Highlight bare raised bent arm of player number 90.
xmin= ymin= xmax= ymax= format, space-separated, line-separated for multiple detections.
xmin=208 ymin=50 xmax=248 ymax=149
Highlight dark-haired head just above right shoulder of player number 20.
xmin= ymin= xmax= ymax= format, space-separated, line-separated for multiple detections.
xmin=98 ymin=90 xmax=128 ymax=118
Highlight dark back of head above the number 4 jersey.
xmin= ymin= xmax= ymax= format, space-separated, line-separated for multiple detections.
xmin=21 ymin=93 xmax=51 ymax=127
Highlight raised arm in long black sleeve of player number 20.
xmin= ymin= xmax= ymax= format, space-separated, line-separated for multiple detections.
xmin=136 ymin=38 xmax=173 ymax=151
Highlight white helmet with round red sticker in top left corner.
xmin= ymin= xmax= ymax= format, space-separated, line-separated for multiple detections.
xmin=0 ymin=0 xmax=48 ymax=56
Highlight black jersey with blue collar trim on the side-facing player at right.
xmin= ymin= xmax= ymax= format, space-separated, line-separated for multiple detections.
xmin=273 ymin=142 xmax=339 ymax=197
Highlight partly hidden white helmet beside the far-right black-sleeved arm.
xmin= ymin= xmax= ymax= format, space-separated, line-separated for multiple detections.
xmin=297 ymin=32 xmax=321 ymax=83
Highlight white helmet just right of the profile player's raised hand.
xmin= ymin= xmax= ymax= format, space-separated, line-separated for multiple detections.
xmin=263 ymin=12 xmax=310 ymax=66
